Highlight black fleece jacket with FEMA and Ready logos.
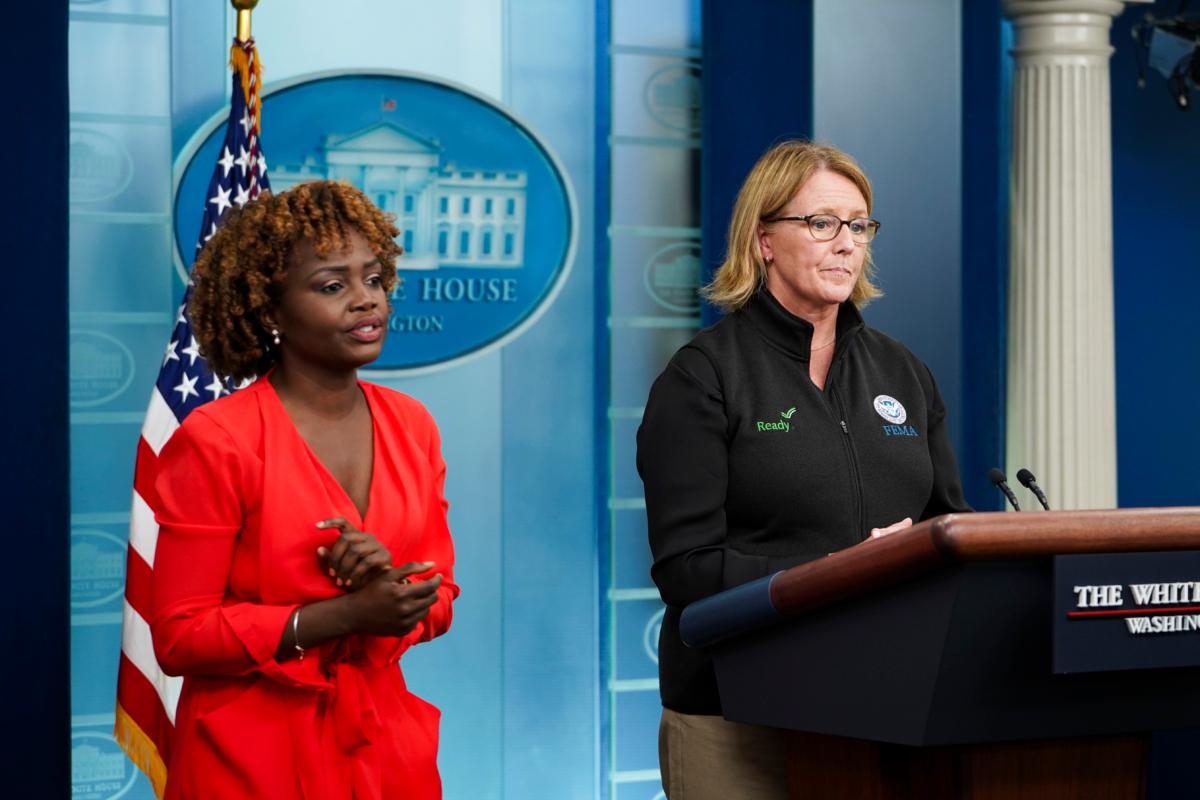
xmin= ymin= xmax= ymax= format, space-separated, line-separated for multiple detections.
xmin=637 ymin=291 xmax=970 ymax=714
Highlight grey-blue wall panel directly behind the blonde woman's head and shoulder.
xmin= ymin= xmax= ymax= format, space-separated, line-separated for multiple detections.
xmin=812 ymin=0 xmax=969 ymax=474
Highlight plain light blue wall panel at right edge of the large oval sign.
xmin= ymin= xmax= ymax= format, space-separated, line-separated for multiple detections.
xmin=499 ymin=0 xmax=600 ymax=798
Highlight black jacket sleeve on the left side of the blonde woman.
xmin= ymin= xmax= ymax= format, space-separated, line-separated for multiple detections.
xmin=637 ymin=348 xmax=767 ymax=607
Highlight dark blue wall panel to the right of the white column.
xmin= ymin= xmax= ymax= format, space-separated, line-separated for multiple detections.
xmin=1111 ymin=0 xmax=1200 ymax=506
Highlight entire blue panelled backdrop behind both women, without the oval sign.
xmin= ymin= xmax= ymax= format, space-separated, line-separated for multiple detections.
xmin=44 ymin=0 xmax=1200 ymax=800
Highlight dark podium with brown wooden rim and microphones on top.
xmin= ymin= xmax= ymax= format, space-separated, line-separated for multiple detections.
xmin=684 ymin=509 xmax=1200 ymax=800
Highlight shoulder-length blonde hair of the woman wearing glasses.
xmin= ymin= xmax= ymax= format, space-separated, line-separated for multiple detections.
xmin=701 ymin=139 xmax=883 ymax=312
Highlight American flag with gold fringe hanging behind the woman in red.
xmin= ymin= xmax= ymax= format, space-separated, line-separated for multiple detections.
xmin=114 ymin=38 xmax=270 ymax=798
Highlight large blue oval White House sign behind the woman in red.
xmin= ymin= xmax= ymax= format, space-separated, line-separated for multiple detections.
xmin=172 ymin=71 xmax=576 ymax=376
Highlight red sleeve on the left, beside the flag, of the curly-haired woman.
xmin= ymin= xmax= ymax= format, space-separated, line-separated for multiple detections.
xmin=150 ymin=414 xmax=304 ymax=682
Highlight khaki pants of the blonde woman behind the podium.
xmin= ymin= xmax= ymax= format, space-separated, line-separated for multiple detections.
xmin=659 ymin=709 xmax=788 ymax=800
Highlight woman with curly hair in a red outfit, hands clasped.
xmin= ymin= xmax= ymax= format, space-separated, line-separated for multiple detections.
xmin=151 ymin=181 xmax=458 ymax=800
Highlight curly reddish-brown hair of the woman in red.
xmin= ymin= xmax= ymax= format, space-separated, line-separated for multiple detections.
xmin=188 ymin=181 xmax=403 ymax=380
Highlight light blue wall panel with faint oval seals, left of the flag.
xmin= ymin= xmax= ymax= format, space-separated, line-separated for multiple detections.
xmin=67 ymin=0 xmax=178 ymax=800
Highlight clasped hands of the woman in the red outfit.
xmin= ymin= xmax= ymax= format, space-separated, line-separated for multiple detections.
xmin=317 ymin=517 xmax=442 ymax=636
